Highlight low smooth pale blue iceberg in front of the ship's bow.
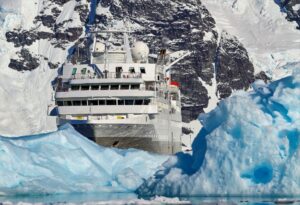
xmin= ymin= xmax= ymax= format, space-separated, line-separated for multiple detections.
xmin=0 ymin=125 xmax=167 ymax=195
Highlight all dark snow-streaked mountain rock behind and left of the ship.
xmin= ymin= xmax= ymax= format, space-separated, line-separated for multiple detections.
xmin=6 ymin=0 xmax=267 ymax=122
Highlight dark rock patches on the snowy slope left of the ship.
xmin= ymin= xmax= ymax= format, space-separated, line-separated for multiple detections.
xmin=5 ymin=0 xmax=89 ymax=71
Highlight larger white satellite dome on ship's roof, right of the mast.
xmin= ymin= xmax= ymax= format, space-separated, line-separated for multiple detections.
xmin=131 ymin=41 xmax=149 ymax=62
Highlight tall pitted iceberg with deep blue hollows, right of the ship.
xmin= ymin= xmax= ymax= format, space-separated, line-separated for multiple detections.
xmin=137 ymin=70 xmax=300 ymax=196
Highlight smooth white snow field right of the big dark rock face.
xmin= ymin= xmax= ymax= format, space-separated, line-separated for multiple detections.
xmin=201 ymin=0 xmax=300 ymax=79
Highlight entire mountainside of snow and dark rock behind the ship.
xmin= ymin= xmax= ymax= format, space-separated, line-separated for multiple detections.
xmin=0 ymin=0 xmax=300 ymax=138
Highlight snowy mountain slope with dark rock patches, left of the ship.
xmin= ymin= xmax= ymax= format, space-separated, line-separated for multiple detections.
xmin=0 ymin=0 xmax=88 ymax=135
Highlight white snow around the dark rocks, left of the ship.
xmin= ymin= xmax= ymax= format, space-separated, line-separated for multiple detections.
xmin=0 ymin=0 xmax=85 ymax=136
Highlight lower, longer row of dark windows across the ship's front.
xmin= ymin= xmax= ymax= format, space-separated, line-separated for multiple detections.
xmin=57 ymin=99 xmax=151 ymax=106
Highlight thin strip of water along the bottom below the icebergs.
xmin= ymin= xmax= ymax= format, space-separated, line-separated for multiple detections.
xmin=0 ymin=193 xmax=300 ymax=205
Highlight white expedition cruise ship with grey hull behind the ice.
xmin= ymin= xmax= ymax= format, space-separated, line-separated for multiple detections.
xmin=55 ymin=30 xmax=189 ymax=154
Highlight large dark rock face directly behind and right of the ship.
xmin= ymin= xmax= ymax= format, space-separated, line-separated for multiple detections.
xmin=91 ymin=0 xmax=260 ymax=122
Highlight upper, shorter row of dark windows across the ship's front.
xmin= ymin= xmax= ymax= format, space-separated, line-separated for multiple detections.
xmin=71 ymin=84 xmax=140 ymax=91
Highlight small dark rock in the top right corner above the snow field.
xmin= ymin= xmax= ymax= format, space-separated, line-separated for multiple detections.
xmin=275 ymin=0 xmax=300 ymax=30
